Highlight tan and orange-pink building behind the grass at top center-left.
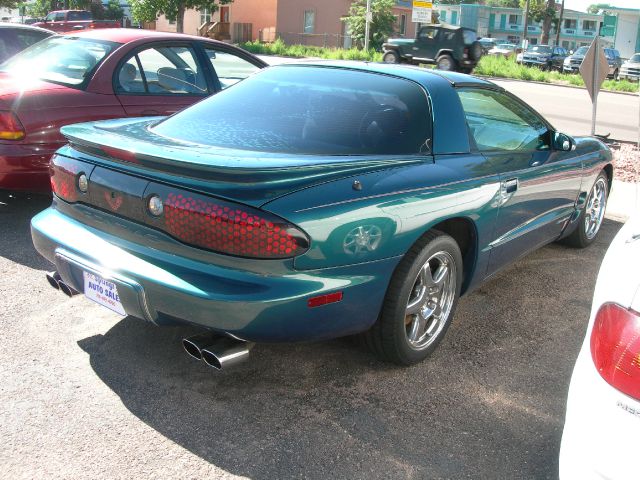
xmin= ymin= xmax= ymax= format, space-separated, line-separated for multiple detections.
xmin=156 ymin=0 xmax=415 ymax=47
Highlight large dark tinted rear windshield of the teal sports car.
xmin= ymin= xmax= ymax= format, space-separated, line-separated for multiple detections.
xmin=152 ymin=66 xmax=430 ymax=155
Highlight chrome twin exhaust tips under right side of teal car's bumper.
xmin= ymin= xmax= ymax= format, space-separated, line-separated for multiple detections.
xmin=182 ymin=332 xmax=253 ymax=370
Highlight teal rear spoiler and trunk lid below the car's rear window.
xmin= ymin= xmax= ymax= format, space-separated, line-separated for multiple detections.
xmin=59 ymin=117 xmax=432 ymax=206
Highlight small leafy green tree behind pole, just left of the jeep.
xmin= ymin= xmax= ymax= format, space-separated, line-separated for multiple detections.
xmin=342 ymin=0 xmax=396 ymax=50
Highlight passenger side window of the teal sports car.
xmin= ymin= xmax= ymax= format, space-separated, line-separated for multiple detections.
xmin=458 ymin=88 xmax=550 ymax=152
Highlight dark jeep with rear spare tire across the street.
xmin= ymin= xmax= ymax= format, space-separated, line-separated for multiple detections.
xmin=382 ymin=24 xmax=482 ymax=73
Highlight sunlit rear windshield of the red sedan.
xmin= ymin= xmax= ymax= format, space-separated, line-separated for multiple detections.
xmin=0 ymin=36 xmax=120 ymax=86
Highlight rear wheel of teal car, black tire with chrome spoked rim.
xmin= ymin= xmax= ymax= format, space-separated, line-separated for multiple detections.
xmin=362 ymin=230 xmax=462 ymax=365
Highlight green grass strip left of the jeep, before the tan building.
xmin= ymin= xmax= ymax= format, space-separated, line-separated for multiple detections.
xmin=240 ymin=38 xmax=382 ymax=62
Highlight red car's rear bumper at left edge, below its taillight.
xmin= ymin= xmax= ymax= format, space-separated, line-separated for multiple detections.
xmin=0 ymin=143 xmax=60 ymax=193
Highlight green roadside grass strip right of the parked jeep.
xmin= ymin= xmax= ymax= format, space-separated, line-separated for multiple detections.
xmin=473 ymin=55 xmax=638 ymax=93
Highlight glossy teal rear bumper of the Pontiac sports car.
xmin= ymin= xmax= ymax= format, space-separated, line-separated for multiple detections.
xmin=31 ymin=207 xmax=400 ymax=342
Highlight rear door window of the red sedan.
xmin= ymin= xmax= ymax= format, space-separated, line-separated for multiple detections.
xmin=114 ymin=46 xmax=208 ymax=95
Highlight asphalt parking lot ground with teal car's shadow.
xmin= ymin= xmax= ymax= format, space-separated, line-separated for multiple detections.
xmin=0 ymin=193 xmax=620 ymax=480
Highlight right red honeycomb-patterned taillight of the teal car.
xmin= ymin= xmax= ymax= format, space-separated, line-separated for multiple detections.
xmin=161 ymin=191 xmax=309 ymax=259
